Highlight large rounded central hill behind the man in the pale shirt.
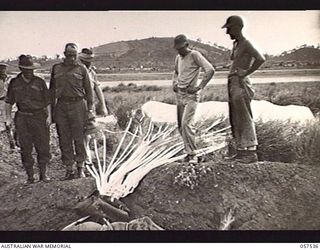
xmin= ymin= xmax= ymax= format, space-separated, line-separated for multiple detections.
xmin=93 ymin=37 xmax=230 ymax=70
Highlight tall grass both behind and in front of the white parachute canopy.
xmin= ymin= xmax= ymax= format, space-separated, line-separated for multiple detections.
xmin=104 ymin=78 xmax=320 ymax=164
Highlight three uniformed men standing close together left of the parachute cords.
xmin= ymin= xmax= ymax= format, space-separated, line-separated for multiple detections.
xmin=4 ymin=43 xmax=107 ymax=183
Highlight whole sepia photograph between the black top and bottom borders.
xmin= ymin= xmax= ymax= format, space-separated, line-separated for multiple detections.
xmin=0 ymin=10 xmax=320 ymax=241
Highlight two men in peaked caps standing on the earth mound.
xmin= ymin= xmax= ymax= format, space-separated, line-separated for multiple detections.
xmin=173 ymin=16 xmax=265 ymax=163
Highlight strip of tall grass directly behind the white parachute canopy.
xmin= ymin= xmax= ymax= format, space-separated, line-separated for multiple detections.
xmin=104 ymin=82 xmax=320 ymax=118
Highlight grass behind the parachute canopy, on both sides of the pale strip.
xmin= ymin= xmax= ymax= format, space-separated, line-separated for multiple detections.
xmin=99 ymin=69 xmax=320 ymax=117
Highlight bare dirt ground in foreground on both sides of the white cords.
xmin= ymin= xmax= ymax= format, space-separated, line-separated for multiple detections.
xmin=0 ymin=125 xmax=320 ymax=231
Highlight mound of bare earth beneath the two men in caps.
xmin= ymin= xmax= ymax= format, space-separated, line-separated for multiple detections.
xmin=123 ymin=161 xmax=320 ymax=230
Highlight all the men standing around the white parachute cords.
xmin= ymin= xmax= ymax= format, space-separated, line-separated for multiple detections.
xmin=0 ymin=16 xmax=265 ymax=183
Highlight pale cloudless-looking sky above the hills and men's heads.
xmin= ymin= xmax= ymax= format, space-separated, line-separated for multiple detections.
xmin=0 ymin=11 xmax=320 ymax=59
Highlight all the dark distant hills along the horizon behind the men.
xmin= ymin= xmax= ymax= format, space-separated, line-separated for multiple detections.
xmin=2 ymin=37 xmax=320 ymax=72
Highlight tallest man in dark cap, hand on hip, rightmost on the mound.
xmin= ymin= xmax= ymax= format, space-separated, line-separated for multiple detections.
xmin=222 ymin=15 xmax=265 ymax=163
